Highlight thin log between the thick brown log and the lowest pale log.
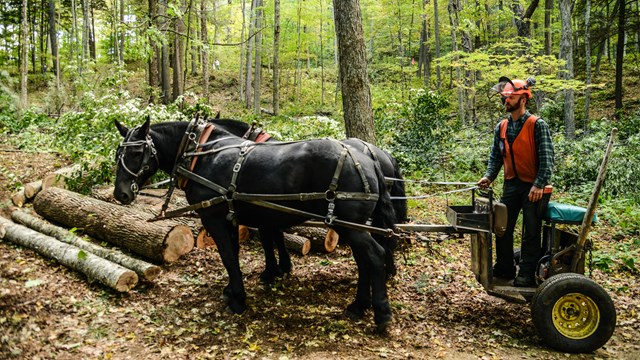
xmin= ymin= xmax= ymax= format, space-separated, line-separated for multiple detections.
xmin=11 ymin=211 xmax=162 ymax=281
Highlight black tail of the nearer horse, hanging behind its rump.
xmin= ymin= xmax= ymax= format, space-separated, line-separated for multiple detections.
xmin=372 ymin=164 xmax=398 ymax=278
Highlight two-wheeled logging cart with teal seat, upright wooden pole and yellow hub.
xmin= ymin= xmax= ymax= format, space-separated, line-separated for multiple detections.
xmin=400 ymin=129 xmax=616 ymax=353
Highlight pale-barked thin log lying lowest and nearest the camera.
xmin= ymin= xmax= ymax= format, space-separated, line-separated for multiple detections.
xmin=0 ymin=217 xmax=138 ymax=292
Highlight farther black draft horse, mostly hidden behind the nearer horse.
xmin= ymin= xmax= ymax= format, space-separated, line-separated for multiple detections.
xmin=208 ymin=118 xmax=407 ymax=283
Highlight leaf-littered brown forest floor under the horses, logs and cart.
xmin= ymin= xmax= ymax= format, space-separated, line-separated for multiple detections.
xmin=0 ymin=142 xmax=640 ymax=359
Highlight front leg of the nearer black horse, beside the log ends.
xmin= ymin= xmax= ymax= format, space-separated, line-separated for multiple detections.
xmin=201 ymin=216 xmax=247 ymax=314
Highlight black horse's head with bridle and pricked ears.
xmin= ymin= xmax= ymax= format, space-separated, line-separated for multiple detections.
xmin=113 ymin=118 xmax=159 ymax=205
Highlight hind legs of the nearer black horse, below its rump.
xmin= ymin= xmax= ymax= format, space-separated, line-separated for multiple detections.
xmin=340 ymin=231 xmax=391 ymax=332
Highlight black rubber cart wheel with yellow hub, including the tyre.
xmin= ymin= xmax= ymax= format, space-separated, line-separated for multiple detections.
xmin=531 ymin=273 xmax=616 ymax=353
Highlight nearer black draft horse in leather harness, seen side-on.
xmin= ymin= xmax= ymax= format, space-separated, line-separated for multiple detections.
xmin=114 ymin=119 xmax=395 ymax=331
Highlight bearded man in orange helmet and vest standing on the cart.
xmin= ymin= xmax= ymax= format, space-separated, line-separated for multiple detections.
xmin=478 ymin=77 xmax=553 ymax=287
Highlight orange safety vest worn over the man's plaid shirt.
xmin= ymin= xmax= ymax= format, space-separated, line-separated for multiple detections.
xmin=500 ymin=115 xmax=539 ymax=183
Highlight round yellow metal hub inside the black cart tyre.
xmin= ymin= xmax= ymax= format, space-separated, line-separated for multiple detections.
xmin=551 ymin=293 xmax=600 ymax=339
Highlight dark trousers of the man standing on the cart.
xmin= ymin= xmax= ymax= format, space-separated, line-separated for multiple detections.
xmin=496 ymin=178 xmax=542 ymax=276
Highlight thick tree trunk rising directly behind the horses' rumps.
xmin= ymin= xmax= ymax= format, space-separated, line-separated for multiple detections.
xmin=333 ymin=0 xmax=376 ymax=144
